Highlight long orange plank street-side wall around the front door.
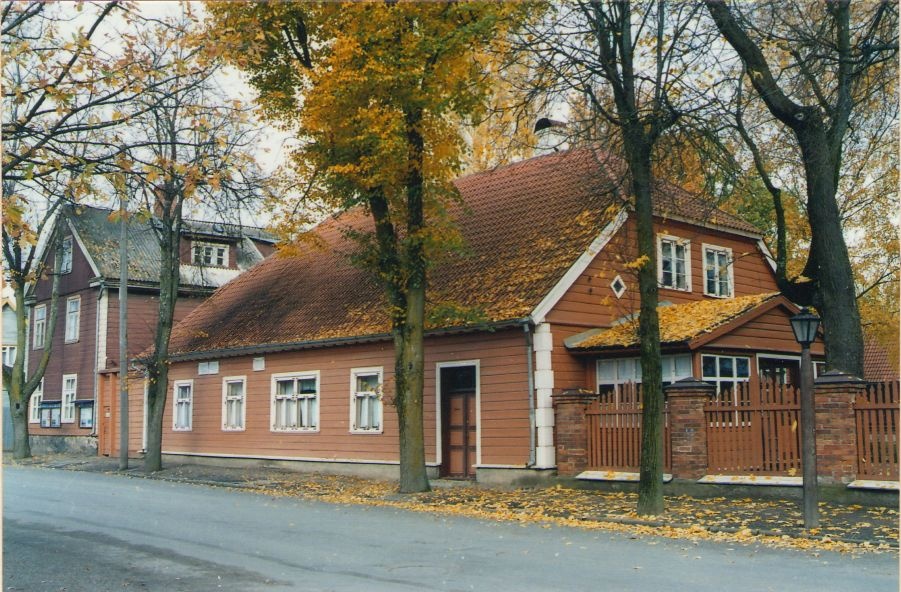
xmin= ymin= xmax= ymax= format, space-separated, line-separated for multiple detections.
xmin=163 ymin=330 xmax=529 ymax=466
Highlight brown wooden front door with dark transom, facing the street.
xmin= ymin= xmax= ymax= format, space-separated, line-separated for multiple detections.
xmin=441 ymin=366 xmax=476 ymax=479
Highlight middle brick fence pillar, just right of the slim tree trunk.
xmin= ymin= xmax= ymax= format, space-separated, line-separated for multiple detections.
xmin=663 ymin=378 xmax=716 ymax=479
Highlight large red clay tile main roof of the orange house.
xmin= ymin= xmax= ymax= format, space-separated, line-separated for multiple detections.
xmin=170 ymin=149 xmax=757 ymax=357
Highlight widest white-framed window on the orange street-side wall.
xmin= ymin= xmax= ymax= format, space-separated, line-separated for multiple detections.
xmin=270 ymin=371 xmax=319 ymax=432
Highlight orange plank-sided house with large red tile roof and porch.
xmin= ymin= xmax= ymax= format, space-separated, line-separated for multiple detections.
xmin=142 ymin=149 xmax=822 ymax=481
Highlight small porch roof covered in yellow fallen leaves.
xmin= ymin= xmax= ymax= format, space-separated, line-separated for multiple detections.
xmin=566 ymin=292 xmax=779 ymax=349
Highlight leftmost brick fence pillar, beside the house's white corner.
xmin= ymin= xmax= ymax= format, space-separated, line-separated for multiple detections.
xmin=551 ymin=389 xmax=598 ymax=476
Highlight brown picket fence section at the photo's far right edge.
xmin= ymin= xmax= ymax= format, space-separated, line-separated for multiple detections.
xmin=854 ymin=381 xmax=899 ymax=481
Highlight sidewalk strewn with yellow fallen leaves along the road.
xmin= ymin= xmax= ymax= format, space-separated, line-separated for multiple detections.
xmin=4 ymin=456 xmax=899 ymax=553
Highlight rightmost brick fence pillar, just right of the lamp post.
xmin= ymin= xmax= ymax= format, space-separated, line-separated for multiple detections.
xmin=813 ymin=370 xmax=867 ymax=483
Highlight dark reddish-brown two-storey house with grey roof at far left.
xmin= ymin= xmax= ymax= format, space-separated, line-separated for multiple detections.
xmin=28 ymin=206 xmax=274 ymax=454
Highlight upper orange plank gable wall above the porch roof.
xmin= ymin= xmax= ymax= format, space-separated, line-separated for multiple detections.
xmin=547 ymin=217 xmax=778 ymax=328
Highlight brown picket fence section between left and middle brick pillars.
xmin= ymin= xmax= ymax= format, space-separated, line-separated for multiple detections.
xmin=586 ymin=382 xmax=672 ymax=472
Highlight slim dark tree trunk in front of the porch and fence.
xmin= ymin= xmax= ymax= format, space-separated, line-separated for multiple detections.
xmin=624 ymin=136 xmax=663 ymax=515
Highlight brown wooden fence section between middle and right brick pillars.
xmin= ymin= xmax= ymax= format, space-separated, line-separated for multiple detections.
xmin=704 ymin=381 xmax=801 ymax=476
